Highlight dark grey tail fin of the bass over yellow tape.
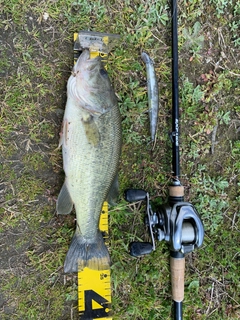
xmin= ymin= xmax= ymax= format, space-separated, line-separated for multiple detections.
xmin=64 ymin=230 xmax=110 ymax=273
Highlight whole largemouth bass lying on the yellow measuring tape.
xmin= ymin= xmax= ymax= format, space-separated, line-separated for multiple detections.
xmin=57 ymin=50 xmax=121 ymax=273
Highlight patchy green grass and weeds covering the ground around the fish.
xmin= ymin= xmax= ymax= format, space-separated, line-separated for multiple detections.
xmin=0 ymin=0 xmax=240 ymax=320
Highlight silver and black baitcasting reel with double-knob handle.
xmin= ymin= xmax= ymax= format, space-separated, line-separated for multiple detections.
xmin=125 ymin=185 xmax=204 ymax=257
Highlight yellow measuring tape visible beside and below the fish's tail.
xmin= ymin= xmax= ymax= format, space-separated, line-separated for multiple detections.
xmin=78 ymin=202 xmax=112 ymax=320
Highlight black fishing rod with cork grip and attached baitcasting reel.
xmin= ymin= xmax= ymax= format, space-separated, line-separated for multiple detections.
xmin=124 ymin=0 xmax=204 ymax=320
